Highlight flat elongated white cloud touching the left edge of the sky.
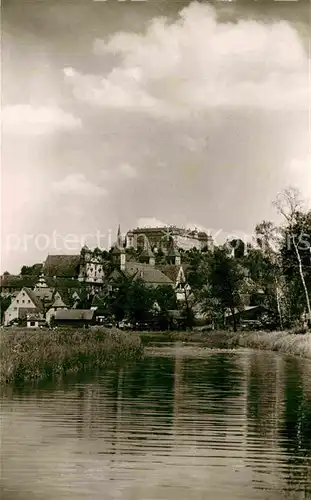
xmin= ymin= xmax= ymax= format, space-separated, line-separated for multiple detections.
xmin=2 ymin=104 xmax=81 ymax=137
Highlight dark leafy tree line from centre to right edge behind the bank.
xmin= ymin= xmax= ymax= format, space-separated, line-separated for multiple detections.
xmin=101 ymin=188 xmax=311 ymax=330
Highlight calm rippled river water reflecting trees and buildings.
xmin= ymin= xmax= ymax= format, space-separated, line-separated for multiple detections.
xmin=1 ymin=344 xmax=311 ymax=500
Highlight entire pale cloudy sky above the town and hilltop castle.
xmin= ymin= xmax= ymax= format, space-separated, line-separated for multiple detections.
xmin=1 ymin=0 xmax=311 ymax=272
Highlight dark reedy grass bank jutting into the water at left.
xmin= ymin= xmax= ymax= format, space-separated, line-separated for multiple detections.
xmin=0 ymin=328 xmax=143 ymax=384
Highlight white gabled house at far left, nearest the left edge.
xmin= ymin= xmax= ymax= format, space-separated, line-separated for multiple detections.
xmin=4 ymin=287 xmax=44 ymax=326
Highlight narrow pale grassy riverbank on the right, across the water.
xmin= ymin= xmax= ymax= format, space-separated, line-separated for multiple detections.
xmin=137 ymin=332 xmax=311 ymax=359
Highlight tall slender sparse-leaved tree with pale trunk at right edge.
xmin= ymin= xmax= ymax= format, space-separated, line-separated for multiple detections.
xmin=274 ymin=188 xmax=311 ymax=322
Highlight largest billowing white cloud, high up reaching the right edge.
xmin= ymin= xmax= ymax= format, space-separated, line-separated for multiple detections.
xmin=64 ymin=3 xmax=310 ymax=118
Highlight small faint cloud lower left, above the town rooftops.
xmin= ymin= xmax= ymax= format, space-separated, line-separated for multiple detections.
xmin=52 ymin=173 xmax=107 ymax=197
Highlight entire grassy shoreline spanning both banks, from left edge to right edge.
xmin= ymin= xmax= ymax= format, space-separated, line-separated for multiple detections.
xmin=0 ymin=327 xmax=311 ymax=386
